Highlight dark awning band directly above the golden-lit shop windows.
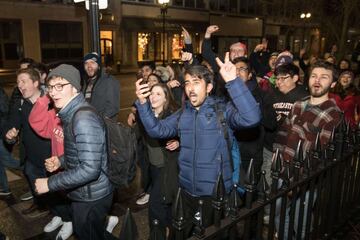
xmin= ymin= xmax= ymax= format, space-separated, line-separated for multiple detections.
xmin=121 ymin=17 xmax=209 ymax=32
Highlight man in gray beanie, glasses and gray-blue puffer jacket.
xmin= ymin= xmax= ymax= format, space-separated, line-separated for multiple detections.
xmin=35 ymin=64 xmax=113 ymax=239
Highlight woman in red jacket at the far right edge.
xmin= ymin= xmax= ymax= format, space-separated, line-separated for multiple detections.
xmin=330 ymin=71 xmax=360 ymax=128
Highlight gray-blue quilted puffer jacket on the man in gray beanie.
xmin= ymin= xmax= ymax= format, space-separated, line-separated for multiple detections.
xmin=48 ymin=94 xmax=113 ymax=202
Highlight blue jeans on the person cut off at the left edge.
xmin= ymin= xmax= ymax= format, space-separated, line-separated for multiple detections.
xmin=0 ymin=140 xmax=20 ymax=192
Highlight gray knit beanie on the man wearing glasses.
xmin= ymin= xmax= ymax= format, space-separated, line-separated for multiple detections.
xmin=48 ymin=64 xmax=81 ymax=91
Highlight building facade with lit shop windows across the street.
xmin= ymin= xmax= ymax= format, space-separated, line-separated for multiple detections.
xmin=0 ymin=0 xmax=358 ymax=68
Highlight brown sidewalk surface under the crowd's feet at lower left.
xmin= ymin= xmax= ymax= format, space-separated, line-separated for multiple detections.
xmin=0 ymin=167 xmax=149 ymax=240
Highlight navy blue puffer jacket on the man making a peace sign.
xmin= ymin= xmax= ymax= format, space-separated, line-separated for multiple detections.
xmin=136 ymin=78 xmax=260 ymax=196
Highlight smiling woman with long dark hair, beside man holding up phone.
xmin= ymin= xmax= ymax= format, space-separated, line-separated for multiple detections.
xmin=139 ymin=83 xmax=179 ymax=239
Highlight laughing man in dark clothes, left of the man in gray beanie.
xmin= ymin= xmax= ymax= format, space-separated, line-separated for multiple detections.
xmin=4 ymin=68 xmax=51 ymax=217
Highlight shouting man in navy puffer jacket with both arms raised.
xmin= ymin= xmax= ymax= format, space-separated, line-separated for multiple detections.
xmin=136 ymin=53 xmax=260 ymax=234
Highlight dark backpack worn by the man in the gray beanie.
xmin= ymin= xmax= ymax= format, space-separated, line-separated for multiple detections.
xmin=75 ymin=106 xmax=137 ymax=187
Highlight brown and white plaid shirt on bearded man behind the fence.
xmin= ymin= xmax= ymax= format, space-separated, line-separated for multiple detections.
xmin=274 ymin=99 xmax=341 ymax=161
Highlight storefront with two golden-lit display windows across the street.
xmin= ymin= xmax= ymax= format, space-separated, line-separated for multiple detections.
xmin=122 ymin=18 xmax=208 ymax=65
